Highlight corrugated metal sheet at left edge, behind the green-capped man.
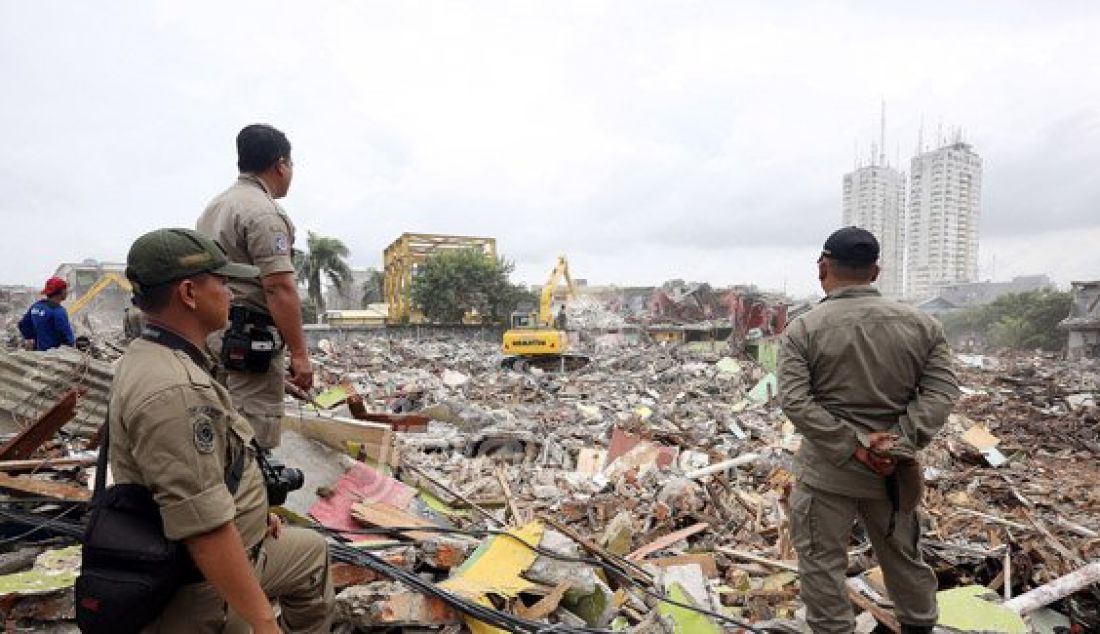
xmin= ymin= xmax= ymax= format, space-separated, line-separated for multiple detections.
xmin=0 ymin=346 xmax=114 ymax=436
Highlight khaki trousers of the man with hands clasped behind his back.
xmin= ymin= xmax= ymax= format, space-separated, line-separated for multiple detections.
xmin=790 ymin=482 xmax=938 ymax=634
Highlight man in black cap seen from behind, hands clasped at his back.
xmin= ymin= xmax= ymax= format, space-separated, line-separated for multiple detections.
xmin=779 ymin=227 xmax=959 ymax=634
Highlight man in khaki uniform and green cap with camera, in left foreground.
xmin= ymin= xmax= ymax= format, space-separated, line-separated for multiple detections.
xmin=109 ymin=229 xmax=332 ymax=633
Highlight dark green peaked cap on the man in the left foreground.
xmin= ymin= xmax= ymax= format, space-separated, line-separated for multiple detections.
xmin=127 ymin=229 xmax=260 ymax=291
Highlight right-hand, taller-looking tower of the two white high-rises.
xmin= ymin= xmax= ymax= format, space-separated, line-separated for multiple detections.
xmin=905 ymin=141 xmax=981 ymax=299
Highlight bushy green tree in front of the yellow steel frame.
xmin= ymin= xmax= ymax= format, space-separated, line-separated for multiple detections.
xmin=411 ymin=249 xmax=530 ymax=324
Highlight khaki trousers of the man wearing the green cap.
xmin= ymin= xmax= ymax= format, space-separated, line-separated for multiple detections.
xmin=144 ymin=526 xmax=333 ymax=634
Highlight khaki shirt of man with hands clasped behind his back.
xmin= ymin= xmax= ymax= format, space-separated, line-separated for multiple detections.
xmin=779 ymin=286 xmax=959 ymax=499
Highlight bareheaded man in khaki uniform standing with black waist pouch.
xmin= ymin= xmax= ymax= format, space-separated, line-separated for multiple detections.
xmin=196 ymin=124 xmax=314 ymax=449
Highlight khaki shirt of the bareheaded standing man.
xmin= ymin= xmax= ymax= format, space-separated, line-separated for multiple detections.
xmin=195 ymin=174 xmax=294 ymax=313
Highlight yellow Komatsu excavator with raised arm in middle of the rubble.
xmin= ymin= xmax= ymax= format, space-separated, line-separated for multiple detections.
xmin=501 ymin=255 xmax=589 ymax=372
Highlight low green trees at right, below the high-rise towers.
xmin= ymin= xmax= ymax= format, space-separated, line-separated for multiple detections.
xmin=944 ymin=291 xmax=1073 ymax=350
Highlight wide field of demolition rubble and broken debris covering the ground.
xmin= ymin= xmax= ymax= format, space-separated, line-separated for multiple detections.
xmin=0 ymin=336 xmax=1100 ymax=633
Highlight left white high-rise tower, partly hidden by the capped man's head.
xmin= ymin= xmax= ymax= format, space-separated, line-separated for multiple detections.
xmin=844 ymin=165 xmax=905 ymax=299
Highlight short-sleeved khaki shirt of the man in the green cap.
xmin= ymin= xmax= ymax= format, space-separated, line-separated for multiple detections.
xmin=109 ymin=339 xmax=267 ymax=548
